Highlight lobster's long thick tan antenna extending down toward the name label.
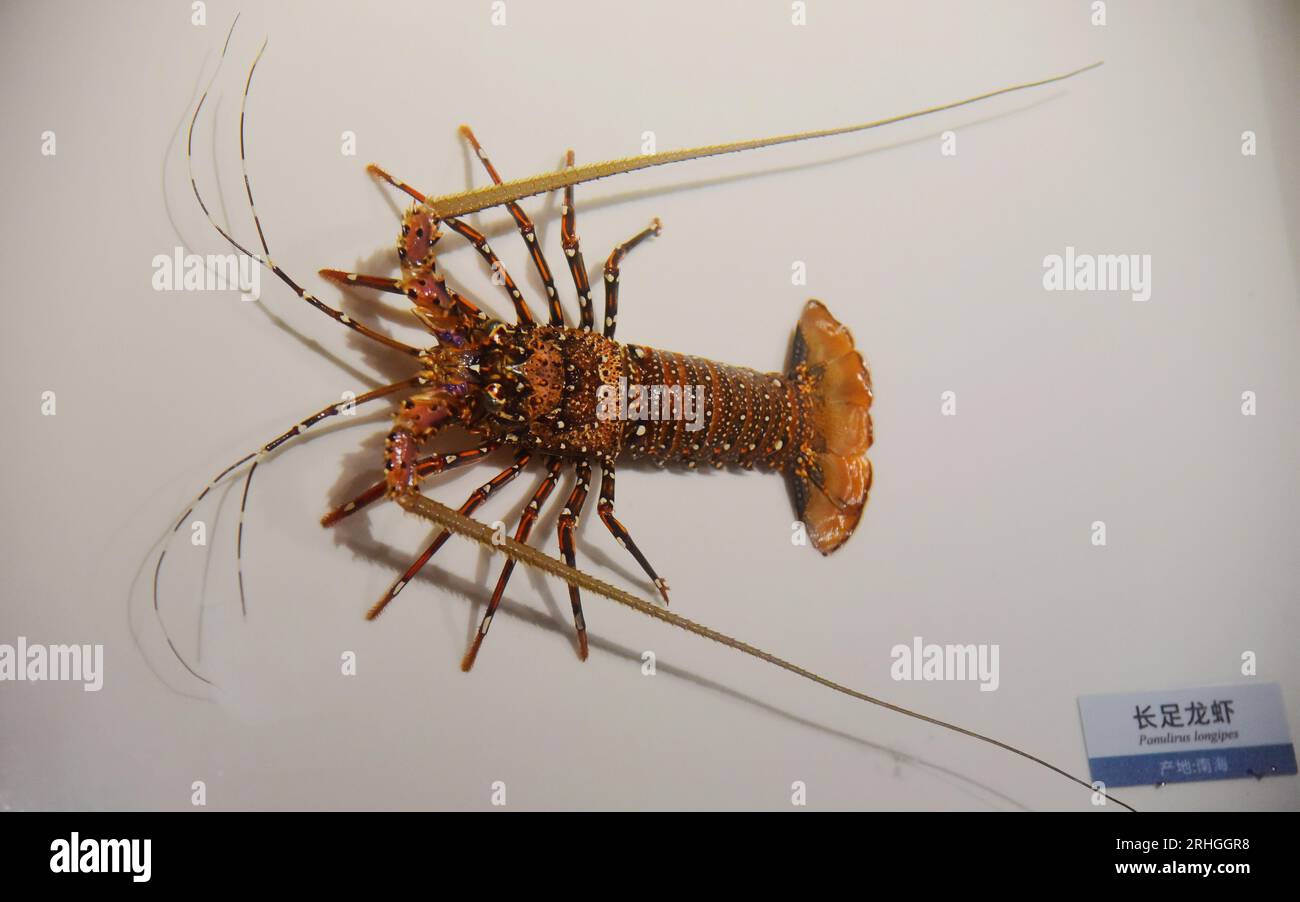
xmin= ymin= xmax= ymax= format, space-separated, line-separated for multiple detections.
xmin=397 ymin=493 xmax=1136 ymax=811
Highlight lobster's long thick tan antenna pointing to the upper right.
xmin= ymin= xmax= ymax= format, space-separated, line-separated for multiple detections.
xmin=424 ymin=60 xmax=1105 ymax=220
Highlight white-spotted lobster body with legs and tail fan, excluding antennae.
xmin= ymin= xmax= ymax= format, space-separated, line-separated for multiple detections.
xmin=340 ymin=139 xmax=871 ymax=669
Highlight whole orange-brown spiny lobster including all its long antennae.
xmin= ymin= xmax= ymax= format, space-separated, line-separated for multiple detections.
xmin=153 ymin=19 xmax=1132 ymax=810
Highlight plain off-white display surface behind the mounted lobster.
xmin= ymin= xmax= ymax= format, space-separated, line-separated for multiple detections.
xmin=0 ymin=0 xmax=1300 ymax=811
